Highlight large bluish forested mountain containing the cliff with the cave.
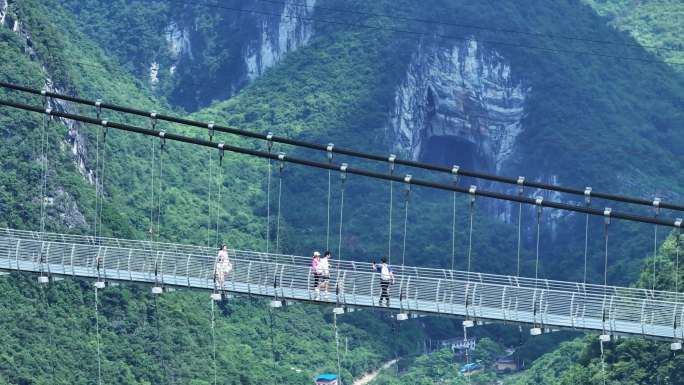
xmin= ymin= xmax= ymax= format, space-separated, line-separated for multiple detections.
xmin=188 ymin=1 xmax=684 ymax=283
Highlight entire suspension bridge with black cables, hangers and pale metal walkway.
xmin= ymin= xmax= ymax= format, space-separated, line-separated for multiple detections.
xmin=0 ymin=83 xmax=684 ymax=350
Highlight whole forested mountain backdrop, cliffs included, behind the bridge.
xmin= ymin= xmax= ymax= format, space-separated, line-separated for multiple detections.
xmin=0 ymin=0 xmax=684 ymax=384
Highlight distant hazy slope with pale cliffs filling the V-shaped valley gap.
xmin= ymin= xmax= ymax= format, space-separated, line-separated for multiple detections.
xmin=60 ymin=0 xmax=316 ymax=111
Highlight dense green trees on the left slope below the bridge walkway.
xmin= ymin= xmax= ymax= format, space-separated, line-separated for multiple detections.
xmin=0 ymin=275 xmax=428 ymax=385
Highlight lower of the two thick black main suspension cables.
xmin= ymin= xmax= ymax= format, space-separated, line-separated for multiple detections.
xmin=0 ymin=100 xmax=676 ymax=227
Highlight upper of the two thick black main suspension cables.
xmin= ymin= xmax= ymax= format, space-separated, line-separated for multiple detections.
xmin=6 ymin=82 xmax=684 ymax=211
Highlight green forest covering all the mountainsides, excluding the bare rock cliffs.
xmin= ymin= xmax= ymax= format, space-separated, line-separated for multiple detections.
xmin=0 ymin=0 xmax=684 ymax=385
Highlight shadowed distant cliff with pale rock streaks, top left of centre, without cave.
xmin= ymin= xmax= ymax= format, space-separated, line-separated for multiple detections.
xmin=157 ymin=0 xmax=316 ymax=110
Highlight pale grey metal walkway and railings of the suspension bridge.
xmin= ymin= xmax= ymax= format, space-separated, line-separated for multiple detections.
xmin=0 ymin=232 xmax=684 ymax=335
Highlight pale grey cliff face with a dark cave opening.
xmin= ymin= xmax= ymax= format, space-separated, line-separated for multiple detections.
xmin=388 ymin=40 xmax=531 ymax=172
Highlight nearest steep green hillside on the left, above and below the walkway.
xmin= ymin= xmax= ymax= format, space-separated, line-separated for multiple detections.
xmin=0 ymin=1 xmax=420 ymax=384
